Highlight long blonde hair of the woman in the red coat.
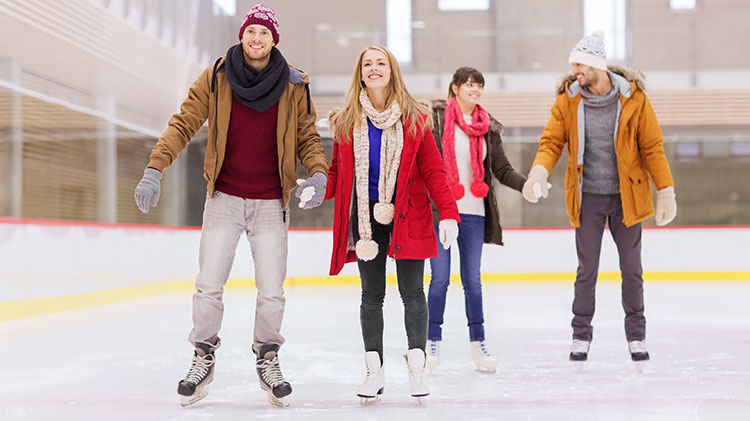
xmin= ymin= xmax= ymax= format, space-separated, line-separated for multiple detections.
xmin=329 ymin=44 xmax=432 ymax=141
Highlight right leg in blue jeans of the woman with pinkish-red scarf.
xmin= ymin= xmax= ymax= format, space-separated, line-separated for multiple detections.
xmin=458 ymin=215 xmax=484 ymax=342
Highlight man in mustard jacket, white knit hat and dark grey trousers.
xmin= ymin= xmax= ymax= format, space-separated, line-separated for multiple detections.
xmin=523 ymin=31 xmax=677 ymax=362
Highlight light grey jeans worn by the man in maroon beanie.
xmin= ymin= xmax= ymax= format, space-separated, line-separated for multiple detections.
xmin=188 ymin=191 xmax=289 ymax=354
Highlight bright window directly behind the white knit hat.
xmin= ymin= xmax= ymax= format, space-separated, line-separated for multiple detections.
xmin=583 ymin=0 xmax=626 ymax=60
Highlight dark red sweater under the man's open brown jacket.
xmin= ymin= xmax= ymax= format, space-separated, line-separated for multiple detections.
xmin=216 ymin=95 xmax=281 ymax=199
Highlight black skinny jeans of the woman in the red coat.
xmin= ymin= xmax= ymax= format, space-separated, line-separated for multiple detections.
xmin=350 ymin=199 xmax=428 ymax=361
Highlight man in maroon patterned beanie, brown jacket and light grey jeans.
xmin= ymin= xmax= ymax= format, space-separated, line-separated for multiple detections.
xmin=135 ymin=4 xmax=328 ymax=406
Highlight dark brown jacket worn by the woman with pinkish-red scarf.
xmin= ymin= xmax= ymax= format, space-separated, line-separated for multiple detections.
xmin=429 ymin=100 xmax=526 ymax=245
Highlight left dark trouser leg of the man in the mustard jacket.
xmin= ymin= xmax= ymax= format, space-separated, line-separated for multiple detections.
xmin=571 ymin=193 xmax=608 ymax=341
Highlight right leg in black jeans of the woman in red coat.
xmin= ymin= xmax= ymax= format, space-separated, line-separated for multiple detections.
xmin=396 ymin=259 xmax=428 ymax=351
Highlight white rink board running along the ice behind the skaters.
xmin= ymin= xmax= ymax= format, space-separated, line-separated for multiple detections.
xmin=0 ymin=221 xmax=750 ymax=301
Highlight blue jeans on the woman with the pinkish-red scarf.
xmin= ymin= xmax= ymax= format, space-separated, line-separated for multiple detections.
xmin=427 ymin=214 xmax=484 ymax=341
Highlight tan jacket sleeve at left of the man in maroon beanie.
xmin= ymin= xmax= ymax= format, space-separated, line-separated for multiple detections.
xmin=148 ymin=67 xmax=212 ymax=173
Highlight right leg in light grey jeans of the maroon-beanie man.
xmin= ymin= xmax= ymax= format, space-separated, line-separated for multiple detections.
xmin=250 ymin=199 xmax=289 ymax=357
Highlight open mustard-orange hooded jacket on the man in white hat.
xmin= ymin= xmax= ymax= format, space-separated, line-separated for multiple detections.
xmin=532 ymin=66 xmax=674 ymax=227
